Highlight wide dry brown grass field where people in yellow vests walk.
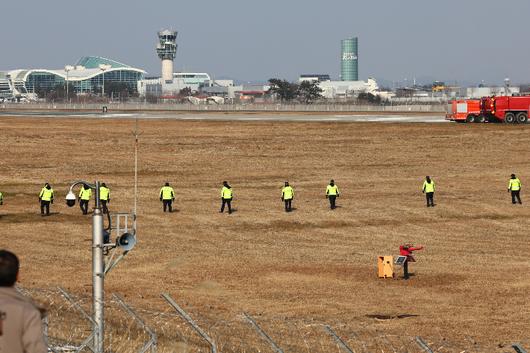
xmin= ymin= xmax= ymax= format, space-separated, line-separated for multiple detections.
xmin=0 ymin=117 xmax=530 ymax=352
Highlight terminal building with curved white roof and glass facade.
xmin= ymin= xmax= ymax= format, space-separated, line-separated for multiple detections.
xmin=0 ymin=56 xmax=146 ymax=100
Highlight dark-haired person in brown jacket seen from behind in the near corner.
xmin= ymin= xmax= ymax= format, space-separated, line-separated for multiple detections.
xmin=0 ymin=250 xmax=48 ymax=353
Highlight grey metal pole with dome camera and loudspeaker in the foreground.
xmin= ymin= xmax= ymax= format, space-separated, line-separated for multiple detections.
xmin=66 ymin=180 xmax=136 ymax=353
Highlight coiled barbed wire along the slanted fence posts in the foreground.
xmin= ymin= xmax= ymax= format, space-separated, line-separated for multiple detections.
xmin=18 ymin=288 xmax=526 ymax=353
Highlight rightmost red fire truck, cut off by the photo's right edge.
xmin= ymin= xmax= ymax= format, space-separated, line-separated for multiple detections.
xmin=480 ymin=96 xmax=530 ymax=124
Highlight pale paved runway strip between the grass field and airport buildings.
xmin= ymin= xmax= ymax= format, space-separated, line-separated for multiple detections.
xmin=0 ymin=111 xmax=447 ymax=123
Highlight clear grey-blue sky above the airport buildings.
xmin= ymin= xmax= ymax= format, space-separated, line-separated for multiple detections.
xmin=0 ymin=0 xmax=530 ymax=84
